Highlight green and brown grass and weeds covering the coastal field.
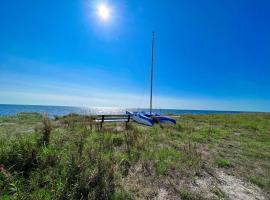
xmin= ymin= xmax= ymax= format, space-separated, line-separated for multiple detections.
xmin=0 ymin=113 xmax=270 ymax=199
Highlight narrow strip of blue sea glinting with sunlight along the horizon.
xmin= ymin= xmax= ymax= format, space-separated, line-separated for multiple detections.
xmin=0 ymin=104 xmax=243 ymax=117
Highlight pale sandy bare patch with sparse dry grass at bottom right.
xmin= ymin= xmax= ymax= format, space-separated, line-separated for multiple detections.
xmin=124 ymin=162 xmax=270 ymax=200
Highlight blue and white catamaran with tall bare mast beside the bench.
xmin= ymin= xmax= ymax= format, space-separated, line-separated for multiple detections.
xmin=126 ymin=32 xmax=176 ymax=126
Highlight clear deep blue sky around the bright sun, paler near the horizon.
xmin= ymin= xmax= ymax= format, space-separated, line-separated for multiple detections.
xmin=0 ymin=0 xmax=270 ymax=111
